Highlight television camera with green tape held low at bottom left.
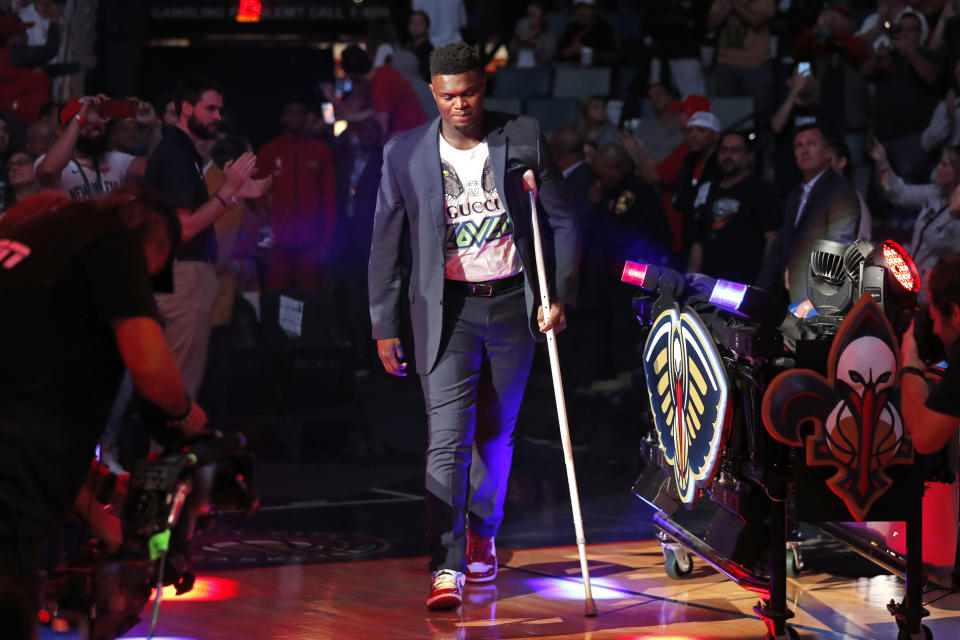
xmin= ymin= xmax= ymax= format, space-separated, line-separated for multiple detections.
xmin=39 ymin=432 xmax=258 ymax=640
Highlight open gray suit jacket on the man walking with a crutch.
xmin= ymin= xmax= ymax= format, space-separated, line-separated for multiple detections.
xmin=368 ymin=111 xmax=579 ymax=374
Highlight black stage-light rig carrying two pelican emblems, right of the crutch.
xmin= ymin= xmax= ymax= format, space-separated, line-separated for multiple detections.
xmin=621 ymin=239 xmax=938 ymax=639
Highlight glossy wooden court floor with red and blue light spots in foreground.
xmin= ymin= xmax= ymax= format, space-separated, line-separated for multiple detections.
xmin=126 ymin=541 xmax=960 ymax=640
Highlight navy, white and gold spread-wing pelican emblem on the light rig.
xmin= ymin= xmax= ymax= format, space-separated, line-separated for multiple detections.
xmin=643 ymin=305 xmax=730 ymax=504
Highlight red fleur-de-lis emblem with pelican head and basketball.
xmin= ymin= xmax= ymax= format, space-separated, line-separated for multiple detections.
xmin=762 ymin=294 xmax=913 ymax=521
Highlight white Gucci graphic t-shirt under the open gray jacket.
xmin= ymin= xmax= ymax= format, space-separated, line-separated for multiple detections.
xmin=437 ymin=133 xmax=521 ymax=282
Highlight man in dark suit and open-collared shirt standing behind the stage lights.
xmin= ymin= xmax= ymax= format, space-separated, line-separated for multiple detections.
xmin=757 ymin=124 xmax=860 ymax=317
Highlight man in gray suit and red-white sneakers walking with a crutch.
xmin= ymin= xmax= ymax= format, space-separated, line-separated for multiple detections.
xmin=368 ymin=43 xmax=578 ymax=609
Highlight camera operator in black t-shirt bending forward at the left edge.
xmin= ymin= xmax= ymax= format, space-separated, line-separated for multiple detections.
xmin=0 ymin=191 xmax=206 ymax=594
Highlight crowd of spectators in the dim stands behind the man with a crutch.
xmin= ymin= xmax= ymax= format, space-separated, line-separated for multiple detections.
xmin=0 ymin=0 xmax=960 ymax=400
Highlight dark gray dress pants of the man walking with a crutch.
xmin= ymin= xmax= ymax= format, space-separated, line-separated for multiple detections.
xmin=420 ymin=285 xmax=535 ymax=571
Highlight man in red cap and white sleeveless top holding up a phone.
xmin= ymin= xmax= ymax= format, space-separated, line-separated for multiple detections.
xmin=36 ymin=95 xmax=159 ymax=200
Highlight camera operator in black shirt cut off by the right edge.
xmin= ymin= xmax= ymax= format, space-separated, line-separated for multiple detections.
xmin=900 ymin=255 xmax=960 ymax=454
